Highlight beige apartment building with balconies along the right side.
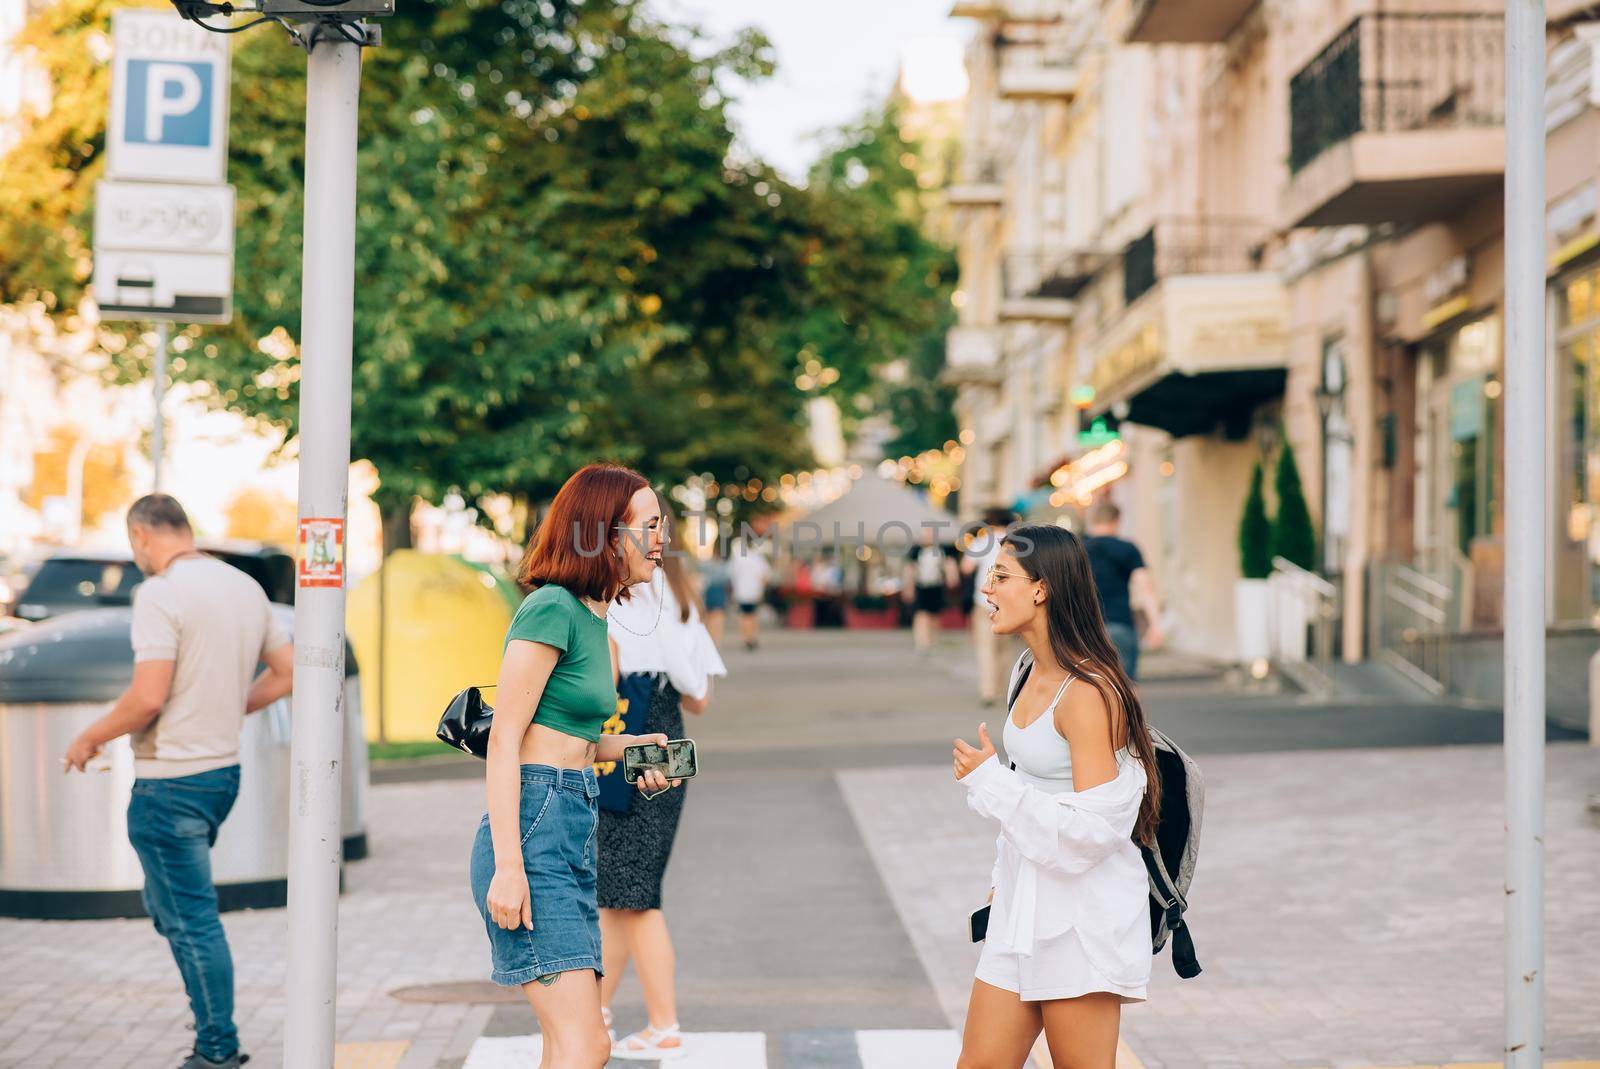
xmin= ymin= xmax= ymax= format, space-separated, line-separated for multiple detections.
xmin=947 ymin=0 xmax=1600 ymax=719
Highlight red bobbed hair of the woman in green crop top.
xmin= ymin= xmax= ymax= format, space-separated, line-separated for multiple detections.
xmin=517 ymin=464 xmax=650 ymax=602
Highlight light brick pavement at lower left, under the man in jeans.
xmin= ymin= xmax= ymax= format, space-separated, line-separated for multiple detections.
xmin=0 ymin=781 xmax=488 ymax=1069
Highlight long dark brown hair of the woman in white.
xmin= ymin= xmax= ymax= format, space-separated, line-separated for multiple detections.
xmin=1000 ymin=523 xmax=1162 ymax=847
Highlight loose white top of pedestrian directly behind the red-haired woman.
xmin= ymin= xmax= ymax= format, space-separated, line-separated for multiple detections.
xmin=606 ymin=578 xmax=728 ymax=699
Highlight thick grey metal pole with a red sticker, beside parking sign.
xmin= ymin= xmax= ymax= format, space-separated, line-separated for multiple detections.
xmin=283 ymin=32 xmax=362 ymax=1069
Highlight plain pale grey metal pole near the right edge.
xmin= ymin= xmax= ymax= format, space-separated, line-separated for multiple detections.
xmin=1506 ymin=0 xmax=1547 ymax=1069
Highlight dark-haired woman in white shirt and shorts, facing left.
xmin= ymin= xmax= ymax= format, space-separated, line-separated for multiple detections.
xmin=955 ymin=525 xmax=1160 ymax=1069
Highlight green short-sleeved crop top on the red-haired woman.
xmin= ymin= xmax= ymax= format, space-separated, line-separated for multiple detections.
xmin=506 ymin=584 xmax=616 ymax=743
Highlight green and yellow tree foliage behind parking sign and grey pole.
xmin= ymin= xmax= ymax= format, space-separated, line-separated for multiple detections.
xmin=0 ymin=0 xmax=954 ymax=509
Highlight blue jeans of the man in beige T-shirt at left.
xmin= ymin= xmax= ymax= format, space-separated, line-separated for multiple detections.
xmin=128 ymin=765 xmax=238 ymax=1061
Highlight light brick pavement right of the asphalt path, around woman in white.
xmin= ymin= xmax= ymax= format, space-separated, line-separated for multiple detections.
xmin=838 ymin=742 xmax=1600 ymax=1069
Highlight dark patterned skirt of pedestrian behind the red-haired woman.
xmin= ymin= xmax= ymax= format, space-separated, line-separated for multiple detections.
xmin=598 ymin=682 xmax=688 ymax=909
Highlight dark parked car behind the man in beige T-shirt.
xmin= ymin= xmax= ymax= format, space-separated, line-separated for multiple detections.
xmin=16 ymin=543 xmax=294 ymax=623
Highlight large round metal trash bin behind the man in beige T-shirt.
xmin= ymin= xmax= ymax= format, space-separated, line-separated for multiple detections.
xmin=0 ymin=605 xmax=368 ymax=919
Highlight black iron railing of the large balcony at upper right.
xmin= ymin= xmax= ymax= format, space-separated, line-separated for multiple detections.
xmin=1290 ymin=11 xmax=1506 ymax=173
